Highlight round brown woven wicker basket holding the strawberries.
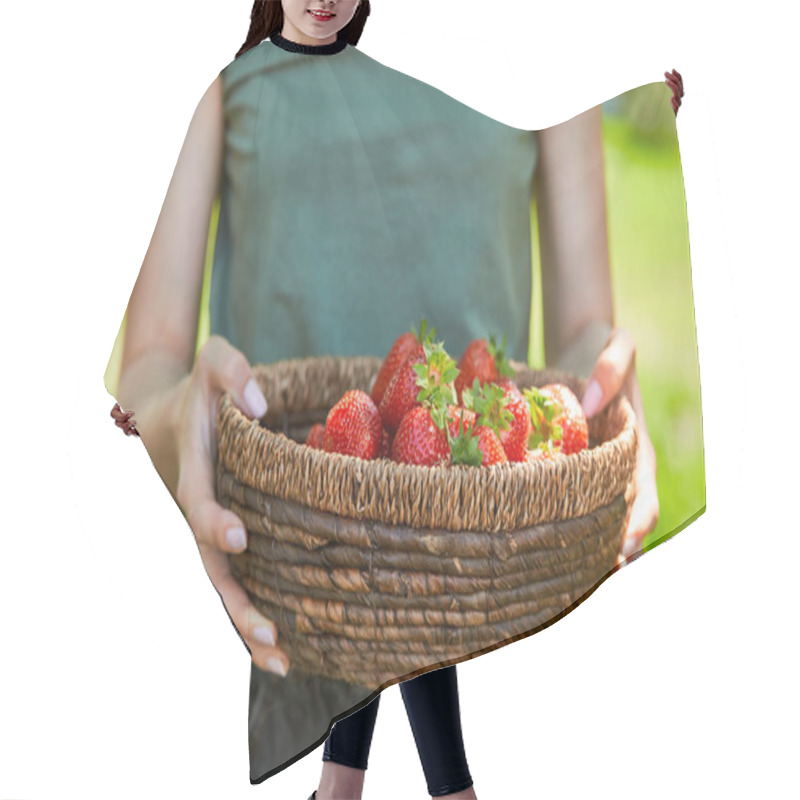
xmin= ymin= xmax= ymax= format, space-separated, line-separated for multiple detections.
xmin=217 ymin=357 xmax=636 ymax=689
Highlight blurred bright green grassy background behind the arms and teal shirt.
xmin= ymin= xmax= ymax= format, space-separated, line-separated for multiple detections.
xmin=105 ymin=82 xmax=706 ymax=550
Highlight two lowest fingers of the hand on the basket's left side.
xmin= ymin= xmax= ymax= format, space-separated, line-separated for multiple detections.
xmin=199 ymin=545 xmax=289 ymax=675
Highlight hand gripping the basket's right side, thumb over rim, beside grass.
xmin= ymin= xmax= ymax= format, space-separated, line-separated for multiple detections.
xmin=581 ymin=328 xmax=659 ymax=563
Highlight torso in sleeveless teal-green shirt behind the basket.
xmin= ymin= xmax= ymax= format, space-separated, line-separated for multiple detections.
xmin=210 ymin=37 xmax=537 ymax=363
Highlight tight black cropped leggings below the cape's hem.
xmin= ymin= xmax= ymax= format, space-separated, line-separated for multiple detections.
xmin=322 ymin=666 xmax=472 ymax=797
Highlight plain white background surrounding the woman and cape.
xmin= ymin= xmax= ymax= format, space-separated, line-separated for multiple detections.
xmin=0 ymin=0 xmax=800 ymax=800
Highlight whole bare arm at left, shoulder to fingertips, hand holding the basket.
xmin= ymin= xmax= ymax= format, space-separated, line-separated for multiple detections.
xmin=112 ymin=76 xmax=289 ymax=675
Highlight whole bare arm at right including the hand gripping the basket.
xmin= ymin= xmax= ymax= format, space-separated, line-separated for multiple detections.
xmin=536 ymin=106 xmax=659 ymax=559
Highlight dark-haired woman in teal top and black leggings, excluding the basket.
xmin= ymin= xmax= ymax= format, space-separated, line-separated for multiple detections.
xmin=118 ymin=0 xmax=658 ymax=800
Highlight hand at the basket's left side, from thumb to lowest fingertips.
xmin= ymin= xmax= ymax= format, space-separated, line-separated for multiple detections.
xmin=177 ymin=336 xmax=289 ymax=675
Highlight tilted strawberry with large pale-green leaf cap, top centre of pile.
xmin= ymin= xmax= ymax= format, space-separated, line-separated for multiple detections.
xmin=379 ymin=340 xmax=456 ymax=434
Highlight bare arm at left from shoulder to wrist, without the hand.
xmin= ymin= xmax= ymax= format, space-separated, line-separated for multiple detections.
xmin=117 ymin=76 xmax=224 ymax=497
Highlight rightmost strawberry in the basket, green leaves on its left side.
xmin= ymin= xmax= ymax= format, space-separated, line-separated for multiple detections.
xmin=525 ymin=383 xmax=589 ymax=455
